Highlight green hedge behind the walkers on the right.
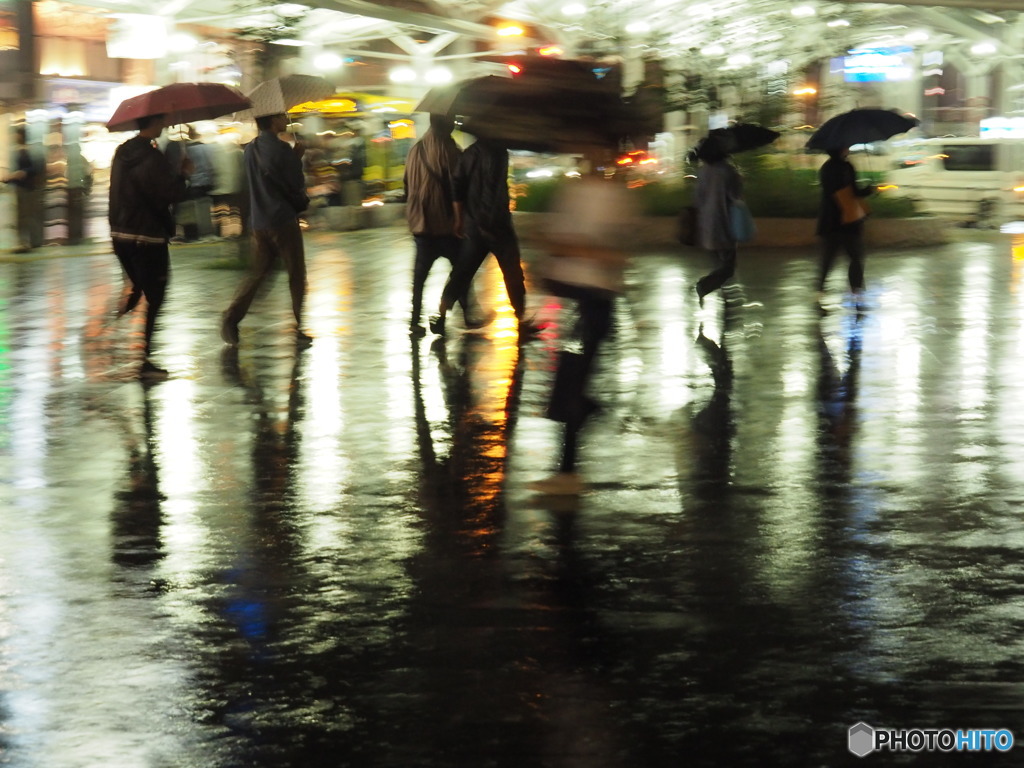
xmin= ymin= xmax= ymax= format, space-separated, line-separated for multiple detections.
xmin=516 ymin=154 xmax=918 ymax=218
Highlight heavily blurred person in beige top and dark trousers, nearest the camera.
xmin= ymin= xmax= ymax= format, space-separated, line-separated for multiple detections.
xmin=529 ymin=150 xmax=639 ymax=496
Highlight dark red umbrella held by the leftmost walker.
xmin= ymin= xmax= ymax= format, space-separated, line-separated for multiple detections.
xmin=106 ymin=83 xmax=250 ymax=131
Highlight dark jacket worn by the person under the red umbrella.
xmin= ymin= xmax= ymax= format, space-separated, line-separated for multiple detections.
xmin=108 ymin=136 xmax=187 ymax=243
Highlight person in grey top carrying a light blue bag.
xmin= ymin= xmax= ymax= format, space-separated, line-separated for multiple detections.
xmin=694 ymin=135 xmax=743 ymax=306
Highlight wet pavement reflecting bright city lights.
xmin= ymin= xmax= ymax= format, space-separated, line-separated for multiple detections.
xmin=0 ymin=227 xmax=1024 ymax=768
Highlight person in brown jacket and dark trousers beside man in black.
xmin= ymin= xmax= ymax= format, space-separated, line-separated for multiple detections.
xmin=404 ymin=115 xmax=473 ymax=336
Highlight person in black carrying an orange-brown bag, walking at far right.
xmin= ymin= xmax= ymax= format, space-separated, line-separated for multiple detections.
xmin=816 ymin=146 xmax=874 ymax=308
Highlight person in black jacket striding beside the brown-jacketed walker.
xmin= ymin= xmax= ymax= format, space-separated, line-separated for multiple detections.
xmin=430 ymin=138 xmax=538 ymax=338
